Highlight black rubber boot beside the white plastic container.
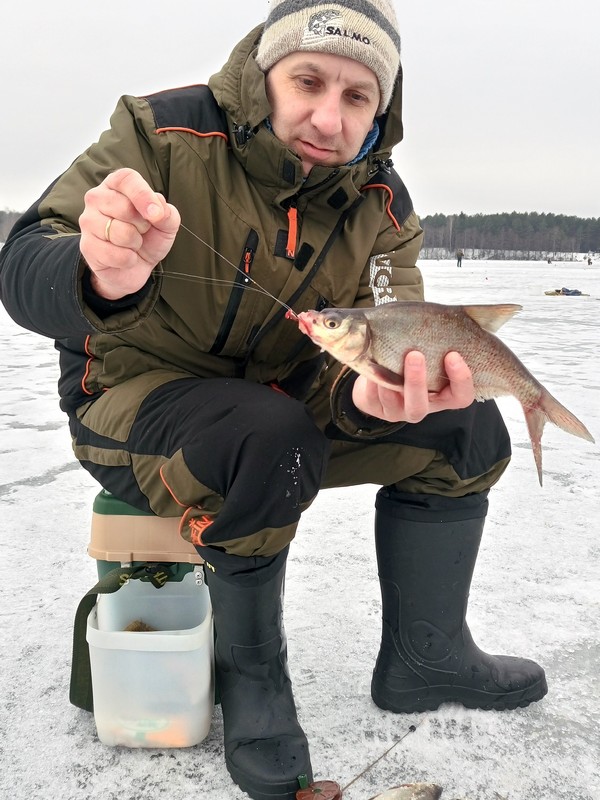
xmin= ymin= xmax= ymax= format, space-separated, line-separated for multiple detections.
xmin=205 ymin=548 xmax=312 ymax=800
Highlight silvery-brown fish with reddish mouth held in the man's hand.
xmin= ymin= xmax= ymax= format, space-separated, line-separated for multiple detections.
xmin=297 ymin=302 xmax=594 ymax=485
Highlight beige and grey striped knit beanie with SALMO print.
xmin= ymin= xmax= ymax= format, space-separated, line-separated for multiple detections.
xmin=256 ymin=0 xmax=400 ymax=114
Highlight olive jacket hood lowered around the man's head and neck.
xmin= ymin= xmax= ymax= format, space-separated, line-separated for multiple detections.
xmin=208 ymin=24 xmax=403 ymax=188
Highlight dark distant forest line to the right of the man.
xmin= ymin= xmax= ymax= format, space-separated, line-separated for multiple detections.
xmin=421 ymin=211 xmax=600 ymax=258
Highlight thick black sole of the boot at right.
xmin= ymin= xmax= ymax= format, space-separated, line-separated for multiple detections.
xmin=371 ymin=678 xmax=548 ymax=714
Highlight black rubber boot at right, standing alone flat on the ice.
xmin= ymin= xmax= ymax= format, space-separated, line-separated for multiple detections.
xmin=371 ymin=488 xmax=548 ymax=712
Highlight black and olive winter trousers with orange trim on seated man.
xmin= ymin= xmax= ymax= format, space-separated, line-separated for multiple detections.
xmin=71 ymin=378 xmax=510 ymax=557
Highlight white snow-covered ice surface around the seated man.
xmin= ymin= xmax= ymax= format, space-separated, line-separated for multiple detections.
xmin=0 ymin=261 xmax=600 ymax=800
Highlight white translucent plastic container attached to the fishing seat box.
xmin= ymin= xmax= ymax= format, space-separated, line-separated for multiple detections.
xmin=87 ymin=572 xmax=214 ymax=748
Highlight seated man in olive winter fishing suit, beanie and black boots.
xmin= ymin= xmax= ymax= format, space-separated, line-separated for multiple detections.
xmin=1 ymin=0 xmax=546 ymax=800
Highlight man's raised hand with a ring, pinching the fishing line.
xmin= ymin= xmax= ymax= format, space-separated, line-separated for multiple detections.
xmin=79 ymin=168 xmax=181 ymax=300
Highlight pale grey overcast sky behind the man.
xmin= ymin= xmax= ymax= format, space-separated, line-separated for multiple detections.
xmin=0 ymin=0 xmax=600 ymax=217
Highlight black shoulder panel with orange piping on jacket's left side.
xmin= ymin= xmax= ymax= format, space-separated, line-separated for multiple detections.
xmin=145 ymin=85 xmax=227 ymax=134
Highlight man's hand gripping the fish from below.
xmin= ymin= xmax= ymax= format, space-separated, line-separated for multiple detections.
xmin=352 ymin=350 xmax=475 ymax=422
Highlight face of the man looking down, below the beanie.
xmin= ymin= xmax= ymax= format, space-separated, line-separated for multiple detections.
xmin=267 ymin=52 xmax=380 ymax=175
